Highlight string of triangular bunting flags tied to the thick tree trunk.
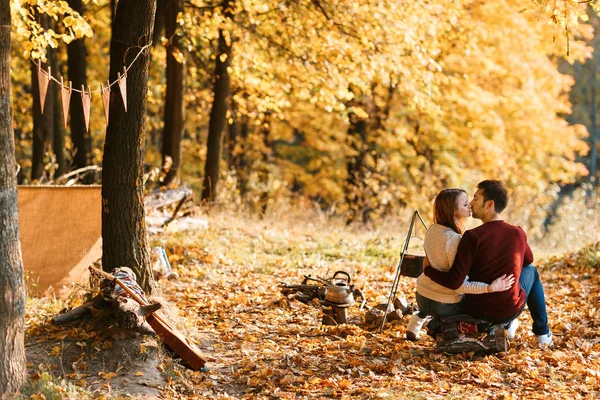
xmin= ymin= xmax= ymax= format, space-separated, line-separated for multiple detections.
xmin=33 ymin=43 xmax=152 ymax=132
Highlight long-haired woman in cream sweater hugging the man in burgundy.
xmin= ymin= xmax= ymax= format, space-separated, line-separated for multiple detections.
xmin=406 ymin=189 xmax=515 ymax=340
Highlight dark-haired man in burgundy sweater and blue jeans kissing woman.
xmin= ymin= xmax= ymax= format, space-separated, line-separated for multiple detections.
xmin=424 ymin=180 xmax=552 ymax=345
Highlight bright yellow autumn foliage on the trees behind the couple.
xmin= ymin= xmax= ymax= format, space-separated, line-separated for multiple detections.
xmin=7 ymin=0 xmax=595 ymax=230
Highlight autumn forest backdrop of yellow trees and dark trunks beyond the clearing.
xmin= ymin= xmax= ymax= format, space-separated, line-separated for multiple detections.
xmin=11 ymin=0 xmax=599 ymax=244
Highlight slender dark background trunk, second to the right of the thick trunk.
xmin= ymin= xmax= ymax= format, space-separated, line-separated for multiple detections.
xmin=201 ymin=0 xmax=234 ymax=203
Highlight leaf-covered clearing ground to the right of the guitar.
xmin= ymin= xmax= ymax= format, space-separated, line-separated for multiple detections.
xmin=24 ymin=212 xmax=600 ymax=399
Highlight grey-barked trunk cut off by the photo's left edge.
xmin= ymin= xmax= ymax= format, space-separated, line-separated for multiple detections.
xmin=0 ymin=0 xmax=26 ymax=399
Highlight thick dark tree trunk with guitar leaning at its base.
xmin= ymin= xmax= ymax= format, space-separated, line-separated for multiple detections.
xmin=102 ymin=0 xmax=156 ymax=291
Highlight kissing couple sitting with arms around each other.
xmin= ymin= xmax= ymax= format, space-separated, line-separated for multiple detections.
xmin=406 ymin=180 xmax=552 ymax=346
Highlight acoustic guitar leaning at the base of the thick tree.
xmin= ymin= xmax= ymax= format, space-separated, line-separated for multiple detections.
xmin=89 ymin=265 xmax=206 ymax=371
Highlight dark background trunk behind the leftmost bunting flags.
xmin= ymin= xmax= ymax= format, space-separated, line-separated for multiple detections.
xmin=31 ymin=49 xmax=56 ymax=180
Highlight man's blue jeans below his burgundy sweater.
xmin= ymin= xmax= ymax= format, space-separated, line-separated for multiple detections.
xmin=492 ymin=265 xmax=550 ymax=335
